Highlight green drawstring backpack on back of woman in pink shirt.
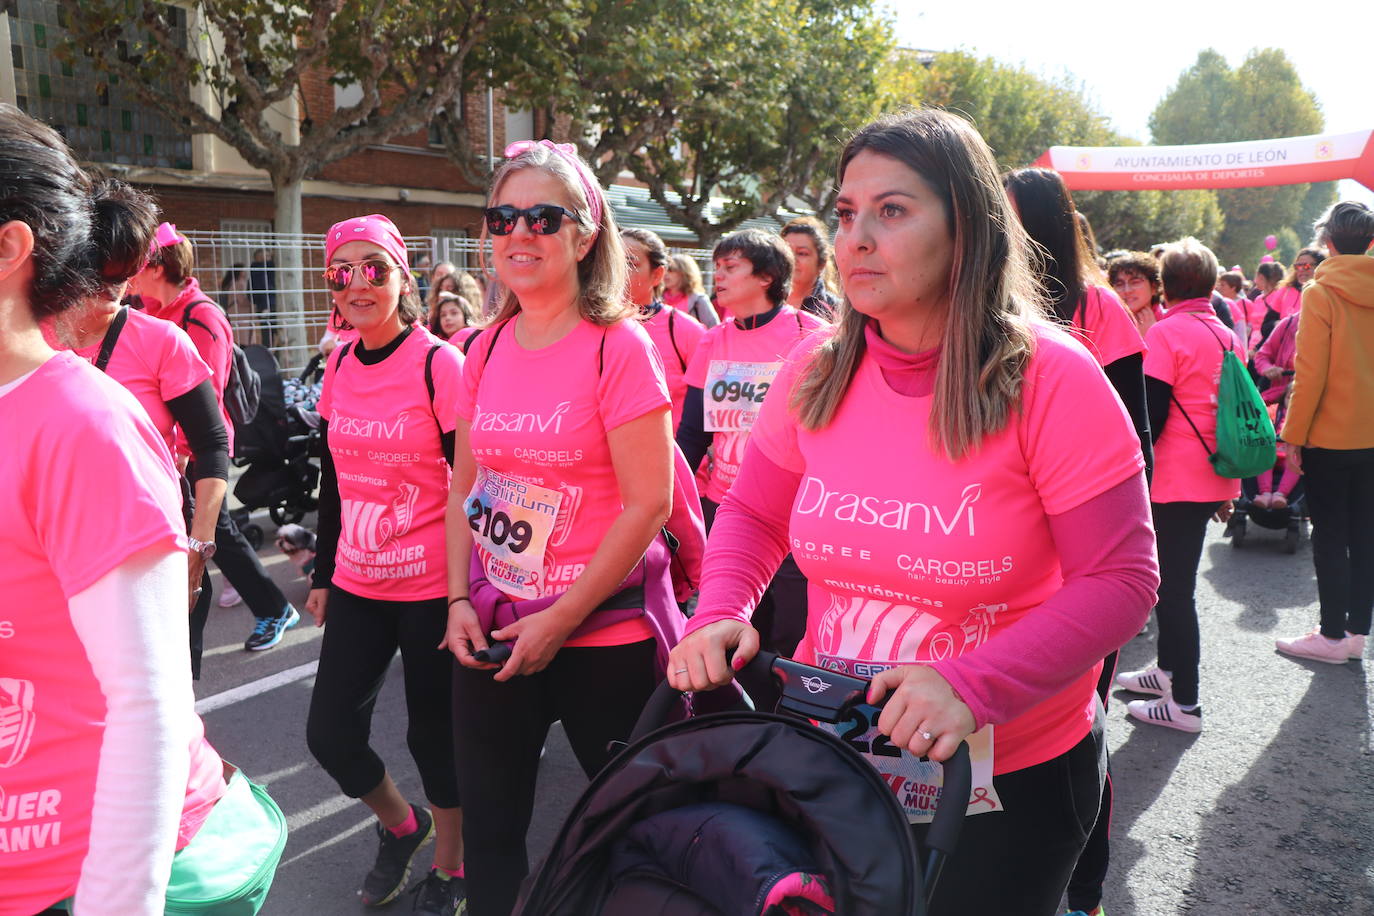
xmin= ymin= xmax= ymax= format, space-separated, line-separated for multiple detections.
xmin=1173 ymin=319 xmax=1278 ymax=479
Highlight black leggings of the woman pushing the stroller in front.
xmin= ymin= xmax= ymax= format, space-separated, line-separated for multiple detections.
xmin=912 ymin=714 xmax=1106 ymax=916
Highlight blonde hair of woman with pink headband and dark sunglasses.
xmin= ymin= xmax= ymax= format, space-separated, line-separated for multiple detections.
xmin=481 ymin=144 xmax=638 ymax=325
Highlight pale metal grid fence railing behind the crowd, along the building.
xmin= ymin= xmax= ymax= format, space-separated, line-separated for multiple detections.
xmin=184 ymin=231 xmax=710 ymax=372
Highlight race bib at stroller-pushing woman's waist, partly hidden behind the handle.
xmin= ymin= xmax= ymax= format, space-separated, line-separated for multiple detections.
xmin=820 ymin=705 xmax=1002 ymax=824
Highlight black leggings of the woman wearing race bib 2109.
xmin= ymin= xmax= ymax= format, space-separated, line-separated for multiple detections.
xmin=453 ymin=640 xmax=658 ymax=916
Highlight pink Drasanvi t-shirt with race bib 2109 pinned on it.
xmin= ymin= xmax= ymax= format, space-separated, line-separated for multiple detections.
xmin=458 ymin=315 xmax=669 ymax=599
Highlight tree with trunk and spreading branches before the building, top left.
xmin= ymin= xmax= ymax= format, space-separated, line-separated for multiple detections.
xmin=58 ymin=0 xmax=507 ymax=346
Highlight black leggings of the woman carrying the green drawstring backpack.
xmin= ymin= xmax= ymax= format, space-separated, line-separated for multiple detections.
xmin=1150 ymin=503 xmax=1221 ymax=706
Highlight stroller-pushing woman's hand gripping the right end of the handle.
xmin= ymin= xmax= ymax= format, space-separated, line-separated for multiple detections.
xmin=868 ymin=665 xmax=976 ymax=762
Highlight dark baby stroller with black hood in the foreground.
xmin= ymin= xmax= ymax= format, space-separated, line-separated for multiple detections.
xmin=515 ymin=652 xmax=973 ymax=916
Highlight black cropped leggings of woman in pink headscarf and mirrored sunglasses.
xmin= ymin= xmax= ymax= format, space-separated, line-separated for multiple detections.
xmin=305 ymin=586 xmax=459 ymax=808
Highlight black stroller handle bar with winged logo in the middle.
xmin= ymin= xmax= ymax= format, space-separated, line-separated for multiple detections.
xmin=628 ymin=651 xmax=973 ymax=894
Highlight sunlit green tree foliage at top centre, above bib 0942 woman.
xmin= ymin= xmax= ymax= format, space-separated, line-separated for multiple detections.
xmin=493 ymin=0 xmax=893 ymax=244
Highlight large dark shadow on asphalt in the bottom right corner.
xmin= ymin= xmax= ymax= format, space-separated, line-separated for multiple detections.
xmin=1184 ymin=662 xmax=1374 ymax=915
